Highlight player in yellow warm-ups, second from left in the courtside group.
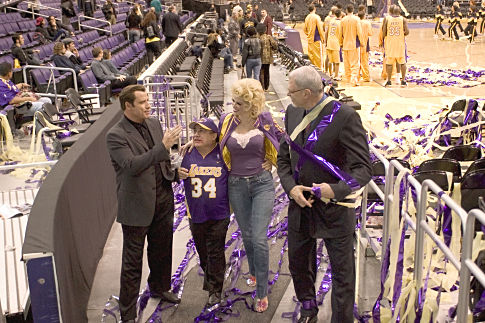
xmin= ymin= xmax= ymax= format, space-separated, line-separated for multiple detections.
xmin=325 ymin=8 xmax=343 ymax=81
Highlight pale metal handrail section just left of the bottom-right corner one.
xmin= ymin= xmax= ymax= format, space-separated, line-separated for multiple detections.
xmin=414 ymin=179 xmax=467 ymax=306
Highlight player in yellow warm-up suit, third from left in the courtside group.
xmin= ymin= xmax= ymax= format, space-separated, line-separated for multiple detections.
xmin=342 ymin=4 xmax=362 ymax=86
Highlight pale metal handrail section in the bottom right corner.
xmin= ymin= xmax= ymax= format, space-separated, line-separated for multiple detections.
xmin=456 ymin=209 xmax=485 ymax=322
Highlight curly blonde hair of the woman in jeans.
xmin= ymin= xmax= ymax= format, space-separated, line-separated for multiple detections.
xmin=231 ymin=78 xmax=264 ymax=119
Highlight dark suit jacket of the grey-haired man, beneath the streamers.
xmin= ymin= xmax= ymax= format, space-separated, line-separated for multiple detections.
xmin=277 ymin=98 xmax=371 ymax=238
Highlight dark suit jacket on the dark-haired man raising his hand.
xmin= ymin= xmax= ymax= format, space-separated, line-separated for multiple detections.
xmin=106 ymin=116 xmax=176 ymax=226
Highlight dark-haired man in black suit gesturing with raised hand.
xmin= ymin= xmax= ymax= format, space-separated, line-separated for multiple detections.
xmin=106 ymin=84 xmax=182 ymax=322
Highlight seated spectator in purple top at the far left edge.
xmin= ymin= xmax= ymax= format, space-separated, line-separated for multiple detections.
xmin=0 ymin=62 xmax=52 ymax=132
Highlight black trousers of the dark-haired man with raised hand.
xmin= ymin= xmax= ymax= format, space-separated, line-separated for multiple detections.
xmin=120 ymin=194 xmax=174 ymax=320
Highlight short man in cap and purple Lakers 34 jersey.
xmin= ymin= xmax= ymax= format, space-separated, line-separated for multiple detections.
xmin=178 ymin=118 xmax=230 ymax=306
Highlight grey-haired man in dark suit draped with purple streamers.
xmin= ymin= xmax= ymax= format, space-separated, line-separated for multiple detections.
xmin=277 ymin=66 xmax=371 ymax=323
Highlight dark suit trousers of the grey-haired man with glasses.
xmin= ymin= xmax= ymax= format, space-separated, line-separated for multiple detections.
xmin=288 ymin=206 xmax=355 ymax=323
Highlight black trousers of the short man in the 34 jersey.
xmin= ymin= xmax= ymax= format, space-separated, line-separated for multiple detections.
xmin=189 ymin=218 xmax=229 ymax=294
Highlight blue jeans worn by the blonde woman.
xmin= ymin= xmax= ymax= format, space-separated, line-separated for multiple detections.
xmin=228 ymin=170 xmax=275 ymax=299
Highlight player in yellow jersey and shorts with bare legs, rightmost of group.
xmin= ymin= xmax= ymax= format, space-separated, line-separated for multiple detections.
xmin=382 ymin=5 xmax=409 ymax=86
